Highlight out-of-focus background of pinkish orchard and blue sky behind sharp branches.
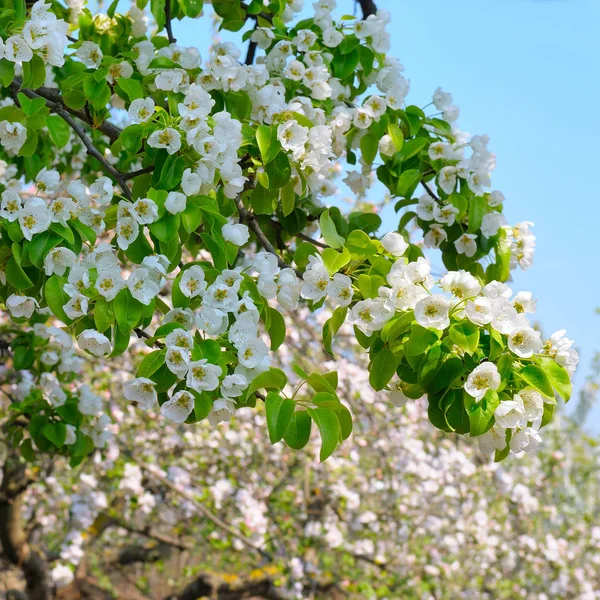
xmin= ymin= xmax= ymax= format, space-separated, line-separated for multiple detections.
xmin=0 ymin=0 xmax=600 ymax=600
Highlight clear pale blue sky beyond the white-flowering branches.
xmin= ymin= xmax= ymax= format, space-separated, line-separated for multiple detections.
xmin=96 ymin=0 xmax=600 ymax=431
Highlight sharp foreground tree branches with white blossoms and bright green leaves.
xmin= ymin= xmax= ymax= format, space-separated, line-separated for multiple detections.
xmin=0 ymin=0 xmax=578 ymax=596
